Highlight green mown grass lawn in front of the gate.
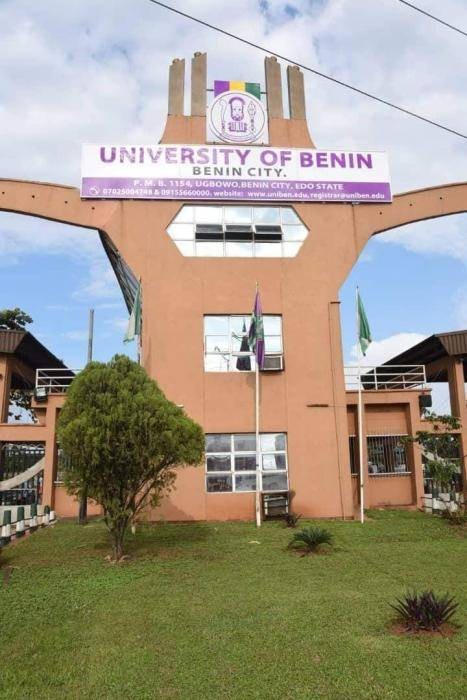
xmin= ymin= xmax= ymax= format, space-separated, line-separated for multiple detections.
xmin=0 ymin=511 xmax=467 ymax=700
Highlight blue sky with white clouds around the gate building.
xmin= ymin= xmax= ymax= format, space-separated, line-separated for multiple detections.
xmin=0 ymin=0 xmax=467 ymax=408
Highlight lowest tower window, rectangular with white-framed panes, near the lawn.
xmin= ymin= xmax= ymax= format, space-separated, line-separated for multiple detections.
xmin=206 ymin=433 xmax=288 ymax=493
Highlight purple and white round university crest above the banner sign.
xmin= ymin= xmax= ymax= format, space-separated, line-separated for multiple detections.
xmin=207 ymin=80 xmax=268 ymax=143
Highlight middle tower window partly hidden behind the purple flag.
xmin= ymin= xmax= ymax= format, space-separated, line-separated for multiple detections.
xmin=204 ymin=314 xmax=282 ymax=372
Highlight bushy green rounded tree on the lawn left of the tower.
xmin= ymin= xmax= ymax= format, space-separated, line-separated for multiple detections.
xmin=58 ymin=355 xmax=204 ymax=560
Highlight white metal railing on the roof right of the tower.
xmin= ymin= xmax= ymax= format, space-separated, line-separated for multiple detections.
xmin=344 ymin=365 xmax=426 ymax=391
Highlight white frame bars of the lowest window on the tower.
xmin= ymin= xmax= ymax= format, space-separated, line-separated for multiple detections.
xmin=204 ymin=432 xmax=289 ymax=494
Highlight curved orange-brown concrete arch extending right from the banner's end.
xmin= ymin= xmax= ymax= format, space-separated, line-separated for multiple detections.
xmin=354 ymin=182 xmax=467 ymax=251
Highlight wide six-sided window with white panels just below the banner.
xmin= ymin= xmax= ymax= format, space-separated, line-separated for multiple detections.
xmin=167 ymin=206 xmax=308 ymax=258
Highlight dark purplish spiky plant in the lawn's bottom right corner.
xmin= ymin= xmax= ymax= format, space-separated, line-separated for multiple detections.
xmin=391 ymin=590 xmax=458 ymax=632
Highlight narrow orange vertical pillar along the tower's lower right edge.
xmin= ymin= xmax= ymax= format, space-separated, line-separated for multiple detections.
xmin=329 ymin=301 xmax=354 ymax=518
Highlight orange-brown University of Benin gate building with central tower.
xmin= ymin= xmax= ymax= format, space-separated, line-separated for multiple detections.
xmin=0 ymin=53 xmax=467 ymax=520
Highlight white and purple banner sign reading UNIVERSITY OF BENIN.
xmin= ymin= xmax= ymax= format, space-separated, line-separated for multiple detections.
xmin=81 ymin=144 xmax=391 ymax=202
